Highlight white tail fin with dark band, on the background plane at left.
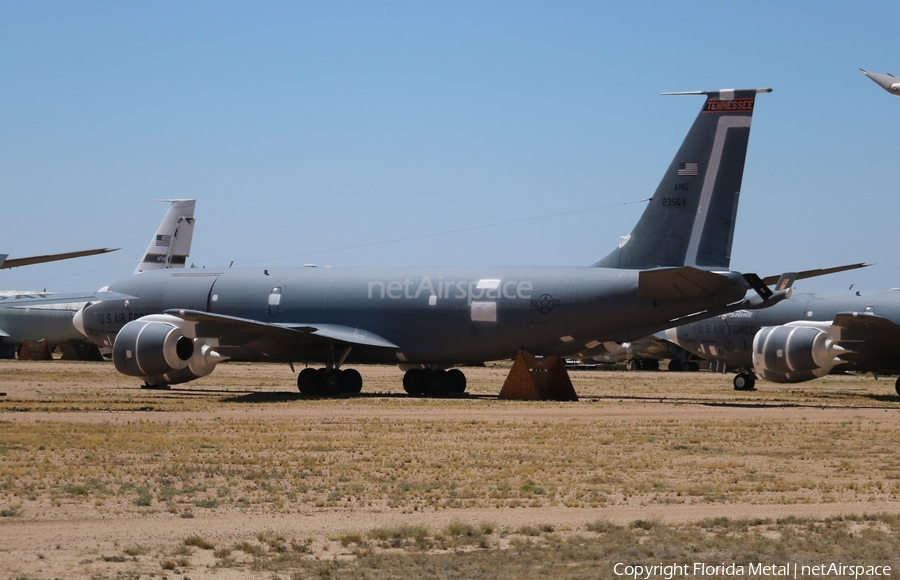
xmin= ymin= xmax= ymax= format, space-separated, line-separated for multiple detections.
xmin=134 ymin=199 xmax=197 ymax=274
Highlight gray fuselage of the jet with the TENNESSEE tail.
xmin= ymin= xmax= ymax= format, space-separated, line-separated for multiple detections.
xmin=83 ymin=267 xmax=746 ymax=365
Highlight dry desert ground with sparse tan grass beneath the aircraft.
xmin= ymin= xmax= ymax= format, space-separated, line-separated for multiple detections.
xmin=0 ymin=360 xmax=900 ymax=579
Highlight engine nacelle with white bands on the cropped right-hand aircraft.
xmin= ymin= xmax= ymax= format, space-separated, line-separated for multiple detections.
xmin=753 ymin=324 xmax=846 ymax=383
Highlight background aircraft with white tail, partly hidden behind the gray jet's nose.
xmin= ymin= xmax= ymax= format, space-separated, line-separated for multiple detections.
xmin=0 ymin=199 xmax=195 ymax=358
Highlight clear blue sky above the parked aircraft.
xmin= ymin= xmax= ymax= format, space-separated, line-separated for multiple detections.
xmin=0 ymin=0 xmax=900 ymax=290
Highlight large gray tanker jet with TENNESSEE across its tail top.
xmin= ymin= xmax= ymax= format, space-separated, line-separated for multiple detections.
xmin=75 ymin=89 xmax=828 ymax=395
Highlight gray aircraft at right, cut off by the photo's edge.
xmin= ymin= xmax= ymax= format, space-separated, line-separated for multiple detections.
xmin=666 ymin=289 xmax=900 ymax=395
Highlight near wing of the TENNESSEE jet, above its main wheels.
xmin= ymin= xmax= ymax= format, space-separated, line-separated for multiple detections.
xmin=165 ymin=310 xmax=399 ymax=354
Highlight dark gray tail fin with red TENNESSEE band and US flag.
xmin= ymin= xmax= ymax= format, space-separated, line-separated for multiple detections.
xmin=594 ymin=89 xmax=772 ymax=270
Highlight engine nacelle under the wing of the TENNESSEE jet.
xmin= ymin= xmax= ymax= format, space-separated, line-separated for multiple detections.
xmin=112 ymin=314 xmax=227 ymax=385
